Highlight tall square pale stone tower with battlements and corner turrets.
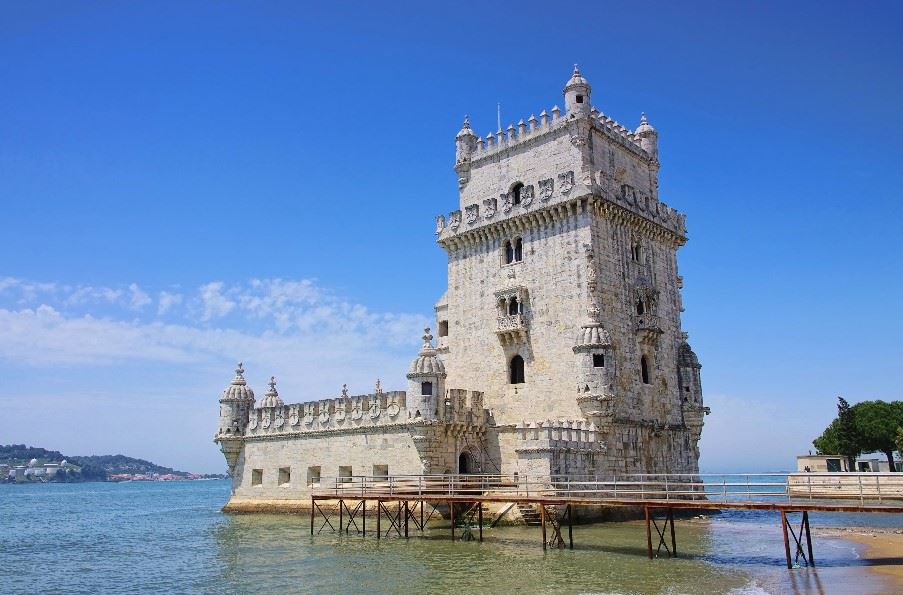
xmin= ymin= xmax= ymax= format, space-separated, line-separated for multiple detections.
xmin=436 ymin=66 xmax=708 ymax=473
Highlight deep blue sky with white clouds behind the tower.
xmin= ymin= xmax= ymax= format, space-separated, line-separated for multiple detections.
xmin=0 ymin=0 xmax=903 ymax=472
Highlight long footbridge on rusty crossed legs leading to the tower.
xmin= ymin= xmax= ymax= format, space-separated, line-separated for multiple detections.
xmin=310 ymin=473 xmax=903 ymax=568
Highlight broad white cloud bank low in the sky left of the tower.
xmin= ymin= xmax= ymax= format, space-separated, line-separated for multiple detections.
xmin=0 ymin=279 xmax=426 ymax=373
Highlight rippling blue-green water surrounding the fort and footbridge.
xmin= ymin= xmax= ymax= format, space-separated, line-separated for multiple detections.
xmin=0 ymin=481 xmax=901 ymax=594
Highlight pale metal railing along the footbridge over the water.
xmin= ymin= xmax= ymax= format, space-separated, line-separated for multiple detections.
xmin=312 ymin=473 xmax=903 ymax=504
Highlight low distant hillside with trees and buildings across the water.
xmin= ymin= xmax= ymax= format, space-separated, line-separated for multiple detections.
xmin=0 ymin=444 xmax=201 ymax=480
